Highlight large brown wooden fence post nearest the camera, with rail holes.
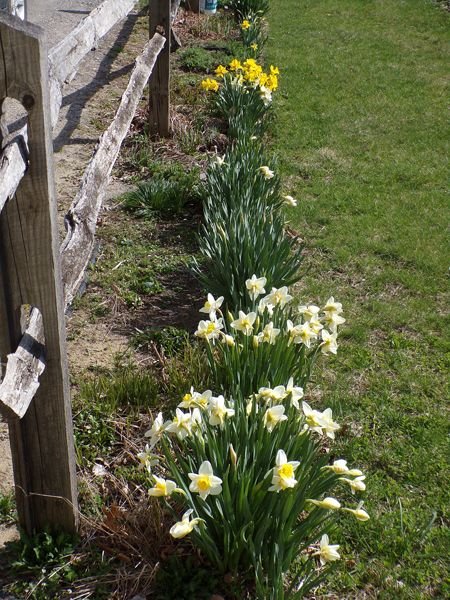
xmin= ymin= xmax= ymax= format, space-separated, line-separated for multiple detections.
xmin=0 ymin=13 xmax=77 ymax=532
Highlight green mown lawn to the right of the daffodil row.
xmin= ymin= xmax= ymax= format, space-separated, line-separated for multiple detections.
xmin=267 ymin=0 xmax=450 ymax=599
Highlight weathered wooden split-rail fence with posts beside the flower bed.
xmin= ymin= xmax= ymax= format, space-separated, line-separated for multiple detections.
xmin=0 ymin=0 xmax=180 ymax=533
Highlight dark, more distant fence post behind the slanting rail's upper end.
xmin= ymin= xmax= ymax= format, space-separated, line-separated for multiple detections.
xmin=149 ymin=0 xmax=172 ymax=137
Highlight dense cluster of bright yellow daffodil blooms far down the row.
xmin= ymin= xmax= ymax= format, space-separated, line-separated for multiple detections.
xmin=201 ymin=57 xmax=280 ymax=106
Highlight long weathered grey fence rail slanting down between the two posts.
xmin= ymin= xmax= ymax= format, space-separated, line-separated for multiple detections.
xmin=61 ymin=33 xmax=166 ymax=304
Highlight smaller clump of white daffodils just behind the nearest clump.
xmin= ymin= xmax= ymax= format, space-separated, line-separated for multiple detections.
xmin=195 ymin=274 xmax=345 ymax=398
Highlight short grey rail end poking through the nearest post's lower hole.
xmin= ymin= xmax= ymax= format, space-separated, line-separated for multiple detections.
xmin=0 ymin=308 xmax=45 ymax=419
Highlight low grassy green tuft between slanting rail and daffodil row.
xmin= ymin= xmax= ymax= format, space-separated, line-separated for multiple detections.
xmin=122 ymin=165 xmax=202 ymax=219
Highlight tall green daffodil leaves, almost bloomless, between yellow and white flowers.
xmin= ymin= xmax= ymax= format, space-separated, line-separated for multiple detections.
xmin=196 ymin=140 xmax=302 ymax=310
